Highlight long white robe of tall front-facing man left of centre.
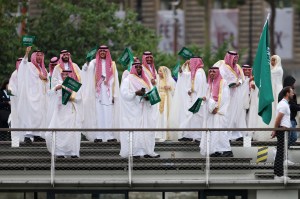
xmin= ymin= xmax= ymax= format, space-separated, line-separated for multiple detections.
xmin=82 ymin=59 xmax=119 ymax=142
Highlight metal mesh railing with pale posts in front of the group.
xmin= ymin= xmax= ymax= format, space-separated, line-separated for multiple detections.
xmin=0 ymin=128 xmax=300 ymax=187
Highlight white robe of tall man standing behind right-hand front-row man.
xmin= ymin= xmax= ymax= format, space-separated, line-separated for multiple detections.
xmin=216 ymin=60 xmax=246 ymax=140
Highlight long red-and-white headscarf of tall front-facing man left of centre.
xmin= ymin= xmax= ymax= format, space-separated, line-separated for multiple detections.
xmin=96 ymin=45 xmax=113 ymax=94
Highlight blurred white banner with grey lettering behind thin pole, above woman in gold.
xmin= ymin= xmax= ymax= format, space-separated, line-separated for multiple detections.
xmin=157 ymin=9 xmax=185 ymax=53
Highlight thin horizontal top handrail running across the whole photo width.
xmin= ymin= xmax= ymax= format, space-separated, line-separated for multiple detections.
xmin=0 ymin=128 xmax=300 ymax=132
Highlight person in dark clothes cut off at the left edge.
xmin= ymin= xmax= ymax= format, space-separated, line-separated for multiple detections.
xmin=0 ymin=80 xmax=10 ymax=141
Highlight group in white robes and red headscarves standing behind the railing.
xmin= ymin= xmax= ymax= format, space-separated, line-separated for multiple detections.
xmin=10 ymin=45 xmax=282 ymax=158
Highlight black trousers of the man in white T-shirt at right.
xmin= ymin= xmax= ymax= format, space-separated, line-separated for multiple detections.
xmin=274 ymin=131 xmax=285 ymax=177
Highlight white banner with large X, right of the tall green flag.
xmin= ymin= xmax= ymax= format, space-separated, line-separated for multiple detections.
xmin=274 ymin=8 xmax=294 ymax=59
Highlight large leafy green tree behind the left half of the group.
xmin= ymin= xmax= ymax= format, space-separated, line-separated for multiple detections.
xmin=28 ymin=0 xmax=158 ymax=70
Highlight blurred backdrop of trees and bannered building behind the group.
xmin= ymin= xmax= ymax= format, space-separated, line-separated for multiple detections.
xmin=0 ymin=0 xmax=300 ymax=88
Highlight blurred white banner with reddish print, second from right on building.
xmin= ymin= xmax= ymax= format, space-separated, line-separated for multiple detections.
xmin=210 ymin=9 xmax=239 ymax=49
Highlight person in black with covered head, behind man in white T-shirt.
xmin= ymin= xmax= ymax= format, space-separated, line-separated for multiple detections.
xmin=278 ymin=76 xmax=300 ymax=147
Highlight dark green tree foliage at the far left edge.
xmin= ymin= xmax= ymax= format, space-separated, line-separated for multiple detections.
xmin=0 ymin=0 xmax=22 ymax=82
